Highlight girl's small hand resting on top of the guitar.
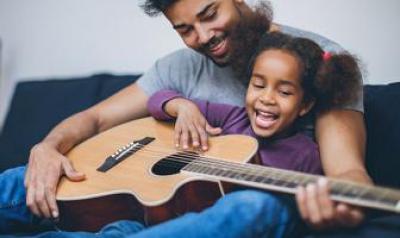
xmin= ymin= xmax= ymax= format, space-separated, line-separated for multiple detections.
xmin=165 ymin=98 xmax=222 ymax=151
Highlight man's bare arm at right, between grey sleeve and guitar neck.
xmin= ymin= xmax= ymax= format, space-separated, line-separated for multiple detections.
xmin=316 ymin=109 xmax=372 ymax=184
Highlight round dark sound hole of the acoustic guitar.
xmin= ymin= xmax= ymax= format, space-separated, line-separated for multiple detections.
xmin=151 ymin=151 xmax=199 ymax=175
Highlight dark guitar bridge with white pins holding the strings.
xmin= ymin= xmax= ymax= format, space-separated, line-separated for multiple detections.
xmin=97 ymin=137 xmax=155 ymax=173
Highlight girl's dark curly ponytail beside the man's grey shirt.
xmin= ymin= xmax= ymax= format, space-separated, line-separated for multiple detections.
xmin=315 ymin=52 xmax=362 ymax=110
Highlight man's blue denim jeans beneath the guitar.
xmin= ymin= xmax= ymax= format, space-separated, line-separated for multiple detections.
xmin=0 ymin=167 xmax=299 ymax=238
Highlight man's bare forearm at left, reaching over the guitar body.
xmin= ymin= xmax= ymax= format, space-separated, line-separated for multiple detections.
xmin=43 ymin=83 xmax=148 ymax=154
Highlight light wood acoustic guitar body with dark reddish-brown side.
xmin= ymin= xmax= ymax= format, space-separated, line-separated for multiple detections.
xmin=57 ymin=118 xmax=257 ymax=231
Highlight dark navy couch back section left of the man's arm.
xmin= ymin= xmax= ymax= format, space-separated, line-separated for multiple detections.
xmin=0 ymin=74 xmax=138 ymax=171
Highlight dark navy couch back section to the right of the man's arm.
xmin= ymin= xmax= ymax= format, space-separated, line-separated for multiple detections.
xmin=364 ymin=83 xmax=400 ymax=188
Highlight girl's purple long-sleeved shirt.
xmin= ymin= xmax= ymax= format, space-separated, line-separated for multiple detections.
xmin=147 ymin=90 xmax=322 ymax=174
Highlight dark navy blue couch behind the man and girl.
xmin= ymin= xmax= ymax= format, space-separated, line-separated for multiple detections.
xmin=0 ymin=74 xmax=400 ymax=234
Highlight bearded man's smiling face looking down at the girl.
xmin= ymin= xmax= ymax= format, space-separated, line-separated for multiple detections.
xmin=164 ymin=0 xmax=247 ymax=65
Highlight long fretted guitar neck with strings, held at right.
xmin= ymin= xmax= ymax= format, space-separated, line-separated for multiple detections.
xmin=182 ymin=158 xmax=400 ymax=213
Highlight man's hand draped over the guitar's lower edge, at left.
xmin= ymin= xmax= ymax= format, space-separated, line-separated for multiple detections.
xmin=24 ymin=143 xmax=85 ymax=218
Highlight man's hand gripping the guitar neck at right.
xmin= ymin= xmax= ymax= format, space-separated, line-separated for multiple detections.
xmin=296 ymin=179 xmax=364 ymax=230
